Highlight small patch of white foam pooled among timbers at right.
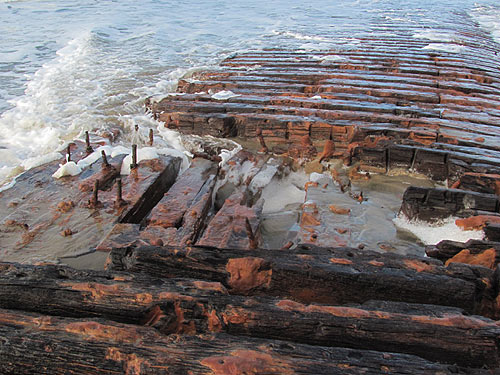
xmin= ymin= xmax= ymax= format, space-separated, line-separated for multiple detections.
xmin=393 ymin=215 xmax=484 ymax=245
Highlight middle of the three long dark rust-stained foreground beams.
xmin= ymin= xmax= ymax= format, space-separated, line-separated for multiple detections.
xmin=0 ymin=264 xmax=500 ymax=367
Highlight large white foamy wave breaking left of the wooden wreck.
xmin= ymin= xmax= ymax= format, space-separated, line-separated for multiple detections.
xmin=0 ymin=33 xmax=101 ymax=188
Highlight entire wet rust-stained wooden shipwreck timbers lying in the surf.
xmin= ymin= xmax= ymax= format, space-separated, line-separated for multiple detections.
xmin=0 ymin=13 xmax=500 ymax=375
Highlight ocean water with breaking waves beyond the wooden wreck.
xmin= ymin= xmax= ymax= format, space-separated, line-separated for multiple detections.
xmin=0 ymin=0 xmax=500 ymax=189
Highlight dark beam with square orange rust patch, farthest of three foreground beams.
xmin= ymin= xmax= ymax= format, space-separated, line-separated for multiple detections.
xmin=105 ymin=247 xmax=493 ymax=312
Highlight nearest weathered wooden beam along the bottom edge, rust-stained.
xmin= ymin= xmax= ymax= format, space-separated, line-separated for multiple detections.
xmin=0 ymin=310 xmax=489 ymax=375
